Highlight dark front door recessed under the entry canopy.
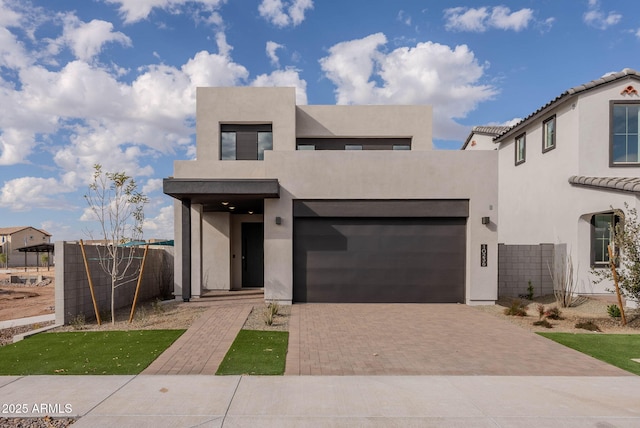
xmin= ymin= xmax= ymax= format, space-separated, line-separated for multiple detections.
xmin=242 ymin=223 xmax=264 ymax=287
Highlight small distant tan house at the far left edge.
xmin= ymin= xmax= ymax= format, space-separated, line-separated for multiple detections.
xmin=0 ymin=226 xmax=51 ymax=267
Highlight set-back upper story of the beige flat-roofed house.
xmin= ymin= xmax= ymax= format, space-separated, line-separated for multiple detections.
xmin=175 ymin=87 xmax=432 ymax=178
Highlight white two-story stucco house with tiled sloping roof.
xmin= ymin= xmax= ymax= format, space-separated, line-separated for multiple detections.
xmin=469 ymin=69 xmax=640 ymax=302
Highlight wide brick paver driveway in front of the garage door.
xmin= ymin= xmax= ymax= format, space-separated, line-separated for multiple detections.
xmin=286 ymin=304 xmax=631 ymax=376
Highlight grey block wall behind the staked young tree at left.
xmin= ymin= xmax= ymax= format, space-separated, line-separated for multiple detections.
xmin=55 ymin=242 xmax=173 ymax=324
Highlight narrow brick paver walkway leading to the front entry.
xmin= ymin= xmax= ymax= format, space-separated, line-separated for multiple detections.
xmin=142 ymin=297 xmax=264 ymax=375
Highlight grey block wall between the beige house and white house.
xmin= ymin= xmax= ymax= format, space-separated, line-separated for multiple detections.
xmin=498 ymin=244 xmax=555 ymax=297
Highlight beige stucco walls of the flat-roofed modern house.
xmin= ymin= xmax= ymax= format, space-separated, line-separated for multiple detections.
xmin=174 ymin=88 xmax=499 ymax=304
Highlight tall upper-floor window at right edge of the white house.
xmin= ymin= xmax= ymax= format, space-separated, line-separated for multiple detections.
xmin=609 ymin=101 xmax=640 ymax=166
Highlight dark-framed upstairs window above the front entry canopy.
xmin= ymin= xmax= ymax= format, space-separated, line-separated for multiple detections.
xmin=220 ymin=124 xmax=273 ymax=160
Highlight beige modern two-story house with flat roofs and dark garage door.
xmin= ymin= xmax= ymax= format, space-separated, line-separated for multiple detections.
xmin=164 ymin=87 xmax=500 ymax=304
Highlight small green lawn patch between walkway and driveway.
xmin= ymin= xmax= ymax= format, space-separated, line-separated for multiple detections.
xmin=216 ymin=330 xmax=289 ymax=375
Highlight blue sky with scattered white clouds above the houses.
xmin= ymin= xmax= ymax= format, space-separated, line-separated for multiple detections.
xmin=0 ymin=0 xmax=640 ymax=241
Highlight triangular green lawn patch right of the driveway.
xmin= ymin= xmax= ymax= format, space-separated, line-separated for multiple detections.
xmin=538 ymin=333 xmax=640 ymax=375
